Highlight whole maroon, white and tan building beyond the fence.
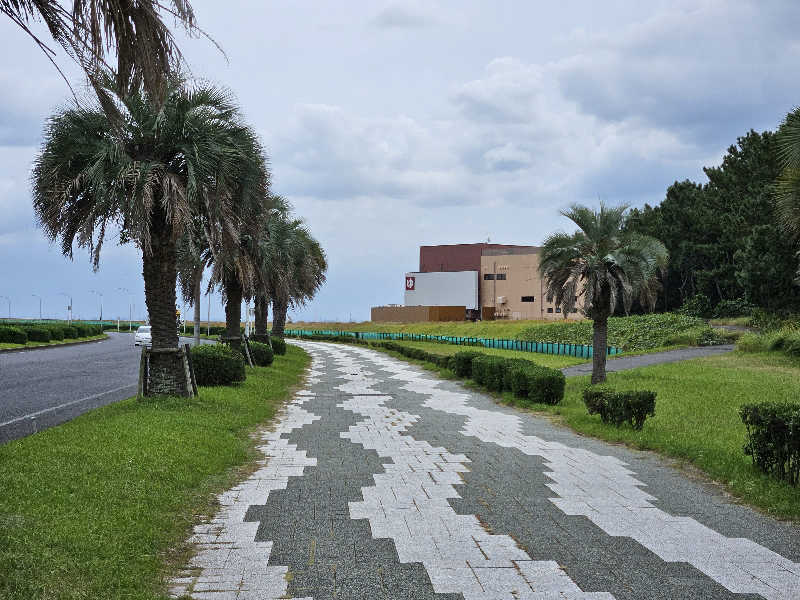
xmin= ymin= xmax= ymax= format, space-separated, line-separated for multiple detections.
xmin=372 ymin=243 xmax=583 ymax=321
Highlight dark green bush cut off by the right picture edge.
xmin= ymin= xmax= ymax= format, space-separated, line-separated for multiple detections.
xmin=739 ymin=402 xmax=800 ymax=485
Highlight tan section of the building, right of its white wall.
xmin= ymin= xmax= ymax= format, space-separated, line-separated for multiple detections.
xmin=479 ymin=246 xmax=583 ymax=320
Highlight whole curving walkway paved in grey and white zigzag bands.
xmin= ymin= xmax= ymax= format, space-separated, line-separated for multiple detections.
xmin=170 ymin=342 xmax=800 ymax=600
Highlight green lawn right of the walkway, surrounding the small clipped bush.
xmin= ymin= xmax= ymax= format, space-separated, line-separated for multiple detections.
xmin=512 ymin=352 xmax=800 ymax=520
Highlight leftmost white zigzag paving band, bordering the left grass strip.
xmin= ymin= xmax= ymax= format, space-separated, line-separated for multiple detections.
xmin=168 ymin=392 xmax=319 ymax=600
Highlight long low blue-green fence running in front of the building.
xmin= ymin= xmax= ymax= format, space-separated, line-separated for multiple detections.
xmin=285 ymin=329 xmax=622 ymax=358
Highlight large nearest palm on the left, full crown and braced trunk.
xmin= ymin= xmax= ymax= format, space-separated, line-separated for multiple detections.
xmin=32 ymin=80 xmax=262 ymax=393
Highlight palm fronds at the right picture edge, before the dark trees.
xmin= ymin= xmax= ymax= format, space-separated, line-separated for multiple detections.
xmin=775 ymin=108 xmax=800 ymax=285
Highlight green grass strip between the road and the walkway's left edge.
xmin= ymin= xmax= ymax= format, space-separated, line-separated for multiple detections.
xmin=0 ymin=346 xmax=309 ymax=600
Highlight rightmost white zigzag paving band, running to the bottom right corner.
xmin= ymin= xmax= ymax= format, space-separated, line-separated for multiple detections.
xmin=326 ymin=347 xmax=800 ymax=600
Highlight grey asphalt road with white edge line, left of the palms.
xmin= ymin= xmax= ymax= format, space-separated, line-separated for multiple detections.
xmin=0 ymin=333 xmax=209 ymax=444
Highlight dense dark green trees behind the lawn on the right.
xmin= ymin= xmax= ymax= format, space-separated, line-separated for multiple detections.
xmin=626 ymin=129 xmax=800 ymax=317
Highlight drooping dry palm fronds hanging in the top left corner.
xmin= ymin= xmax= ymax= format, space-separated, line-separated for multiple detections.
xmin=0 ymin=0 xmax=199 ymax=97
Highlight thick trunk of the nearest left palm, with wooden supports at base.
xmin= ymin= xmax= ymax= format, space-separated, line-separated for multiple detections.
xmin=142 ymin=213 xmax=189 ymax=396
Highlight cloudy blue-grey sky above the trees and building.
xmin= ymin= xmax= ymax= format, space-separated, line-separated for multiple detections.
xmin=0 ymin=0 xmax=800 ymax=320
